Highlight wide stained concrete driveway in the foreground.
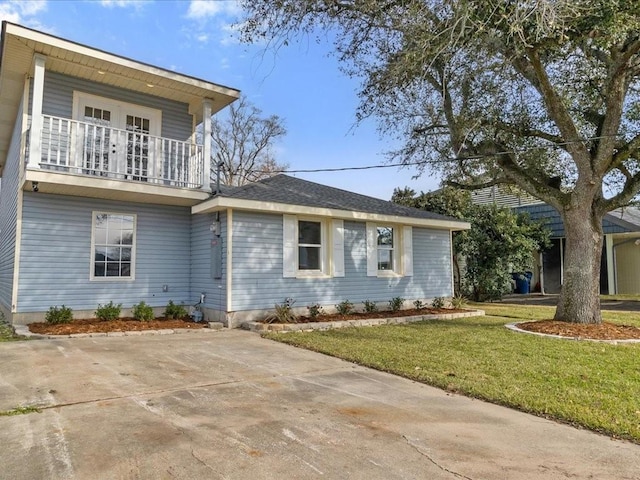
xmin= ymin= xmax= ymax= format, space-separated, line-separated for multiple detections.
xmin=0 ymin=330 xmax=640 ymax=480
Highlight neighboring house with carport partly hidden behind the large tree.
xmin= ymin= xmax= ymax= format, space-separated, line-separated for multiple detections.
xmin=472 ymin=186 xmax=640 ymax=294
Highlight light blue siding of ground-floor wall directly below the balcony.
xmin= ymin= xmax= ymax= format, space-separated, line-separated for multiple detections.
xmin=17 ymin=192 xmax=192 ymax=312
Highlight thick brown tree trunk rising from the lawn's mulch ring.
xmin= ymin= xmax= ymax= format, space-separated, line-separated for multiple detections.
xmin=554 ymin=205 xmax=603 ymax=324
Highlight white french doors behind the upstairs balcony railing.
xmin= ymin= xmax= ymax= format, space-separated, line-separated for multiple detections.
xmin=74 ymin=92 xmax=161 ymax=181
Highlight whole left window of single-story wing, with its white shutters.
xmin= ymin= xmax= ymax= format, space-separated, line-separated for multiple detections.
xmin=282 ymin=215 xmax=344 ymax=277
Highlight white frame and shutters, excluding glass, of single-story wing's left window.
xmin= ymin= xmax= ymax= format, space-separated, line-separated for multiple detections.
xmin=282 ymin=215 xmax=344 ymax=278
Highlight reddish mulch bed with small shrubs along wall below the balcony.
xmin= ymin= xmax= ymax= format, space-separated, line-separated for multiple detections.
xmin=29 ymin=318 xmax=208 ymax=335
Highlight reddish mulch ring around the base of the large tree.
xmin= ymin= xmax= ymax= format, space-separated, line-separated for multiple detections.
xmin=518 ymin=320 xmax=640 ymax=340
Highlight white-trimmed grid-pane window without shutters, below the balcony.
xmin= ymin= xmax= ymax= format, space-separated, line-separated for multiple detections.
xmin=91 ymin=212 xmax=136 ymax=280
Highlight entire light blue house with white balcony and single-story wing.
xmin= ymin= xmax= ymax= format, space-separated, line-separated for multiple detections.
xmin=0 ymin=22 xmax=469 ymax=326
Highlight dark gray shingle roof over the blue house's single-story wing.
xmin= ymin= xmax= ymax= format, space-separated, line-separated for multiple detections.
xmin=220 ymin=175 xmax=461 ymax=221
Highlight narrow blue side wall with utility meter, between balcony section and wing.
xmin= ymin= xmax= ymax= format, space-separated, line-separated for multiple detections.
xmin=191 ymin=213 xmax=227 ymax=311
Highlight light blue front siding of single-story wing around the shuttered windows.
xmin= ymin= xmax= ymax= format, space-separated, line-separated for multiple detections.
xmin=232 ymin=212 xmax=452 ymax=311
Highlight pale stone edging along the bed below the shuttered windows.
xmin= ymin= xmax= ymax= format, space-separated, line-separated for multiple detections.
xmin=241 ymin=310 xmax=484 ymax=333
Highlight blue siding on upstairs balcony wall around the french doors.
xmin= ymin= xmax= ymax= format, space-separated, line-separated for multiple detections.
xmin=42 ymin=72 xmax=193 ymax=141
